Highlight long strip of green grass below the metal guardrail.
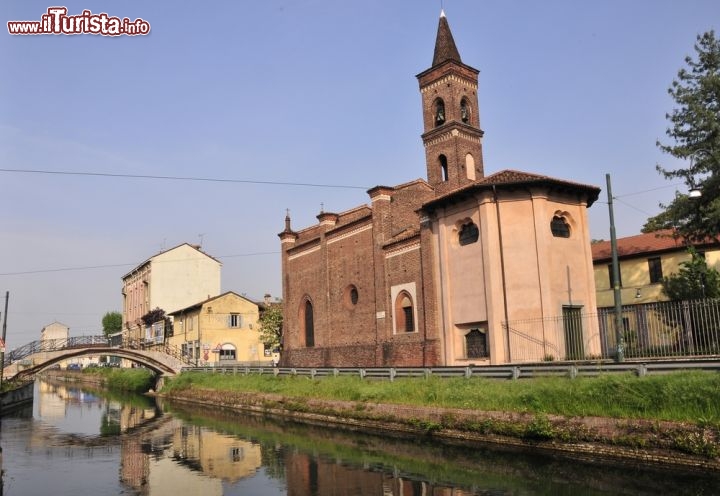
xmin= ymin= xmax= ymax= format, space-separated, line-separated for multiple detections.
xmin=163 ymin=371 xmax=720 ymax=426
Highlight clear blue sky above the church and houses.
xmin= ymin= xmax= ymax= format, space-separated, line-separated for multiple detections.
xmin=0 ymin=0 xmax=720 ymax=348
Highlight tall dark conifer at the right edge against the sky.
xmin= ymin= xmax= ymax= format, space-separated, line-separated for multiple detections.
xmin=643 ymin=30 xmax=720 ymax=240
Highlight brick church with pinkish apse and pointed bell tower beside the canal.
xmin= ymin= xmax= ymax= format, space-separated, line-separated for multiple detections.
xmin=279 ymin=13 xmax=600 ymax=367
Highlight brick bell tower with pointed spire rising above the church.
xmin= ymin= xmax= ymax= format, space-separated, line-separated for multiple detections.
xmin=417 ymin=11 xmax=484 ymax=194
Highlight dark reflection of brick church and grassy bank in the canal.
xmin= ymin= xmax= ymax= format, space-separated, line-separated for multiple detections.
xmin=165 ymin=405 xmax=720 ymax=496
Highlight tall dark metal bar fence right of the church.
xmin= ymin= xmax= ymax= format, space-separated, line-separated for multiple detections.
xmin=503 ymin=299 xmax=720 ymax=363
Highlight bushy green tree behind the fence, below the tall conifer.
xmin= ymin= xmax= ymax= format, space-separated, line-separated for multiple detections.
xmin=662 ymin=247 xmax=720 ymax=300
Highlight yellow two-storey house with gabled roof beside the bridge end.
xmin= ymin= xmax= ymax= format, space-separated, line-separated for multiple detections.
xmin=167 ymin=291 xmax=272 ymax=365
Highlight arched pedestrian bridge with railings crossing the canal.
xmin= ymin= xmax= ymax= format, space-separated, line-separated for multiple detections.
xmin=3 ymin=336 xmax=193 ymax=379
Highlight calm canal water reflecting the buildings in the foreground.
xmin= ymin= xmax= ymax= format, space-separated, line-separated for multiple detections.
xmin=0 ymin=381 xmax=720 ymax=496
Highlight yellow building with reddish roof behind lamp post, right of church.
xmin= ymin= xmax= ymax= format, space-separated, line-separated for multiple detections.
xmin=592 ymin=230 xmax=720 ymax=308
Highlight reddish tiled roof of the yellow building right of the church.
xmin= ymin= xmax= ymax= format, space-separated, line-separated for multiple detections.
xmin=591 ymin=229 xmax=720 ymax=262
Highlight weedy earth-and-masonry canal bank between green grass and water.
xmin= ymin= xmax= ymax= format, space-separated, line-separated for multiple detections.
xmin=160 ymin=388 xmax=720 ymax=472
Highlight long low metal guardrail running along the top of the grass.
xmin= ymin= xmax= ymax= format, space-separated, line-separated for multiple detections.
xmin=182 ymin=360 xmax=720 ymax=381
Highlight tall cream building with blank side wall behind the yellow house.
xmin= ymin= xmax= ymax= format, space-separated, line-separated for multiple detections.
xmin=122 ymin=243 xmax=222 ymax=340
